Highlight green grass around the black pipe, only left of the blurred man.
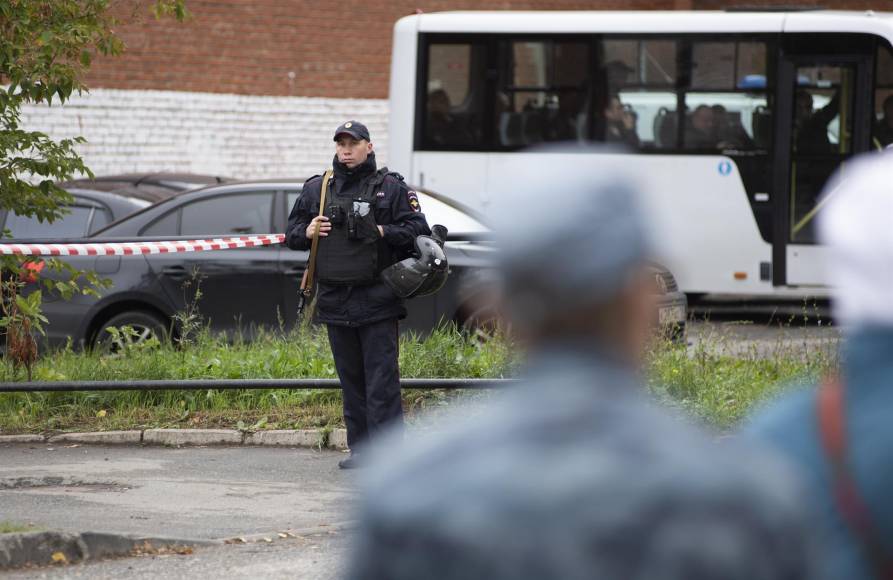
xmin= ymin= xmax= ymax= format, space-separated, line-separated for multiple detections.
xmin=0 ymin=328 xmax=513 ymax=433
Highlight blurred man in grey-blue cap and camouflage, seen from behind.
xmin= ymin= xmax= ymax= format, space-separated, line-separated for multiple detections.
xmin=348 ymin=148 xmax=812 ymax=580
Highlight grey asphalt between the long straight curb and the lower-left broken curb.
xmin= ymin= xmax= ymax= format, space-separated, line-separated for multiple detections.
xmin=0 ymin=444 xmax=355 ymax=539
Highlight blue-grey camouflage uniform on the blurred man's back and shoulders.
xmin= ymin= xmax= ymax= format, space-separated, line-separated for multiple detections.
xmin=348 ymin=345 xmax=815 ymax=580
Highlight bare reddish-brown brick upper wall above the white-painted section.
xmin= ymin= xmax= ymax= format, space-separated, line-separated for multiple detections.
xmin=88 ymin=0 xmax=676 ymax=99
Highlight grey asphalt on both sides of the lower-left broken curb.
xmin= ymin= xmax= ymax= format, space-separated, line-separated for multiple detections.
xmin=0 ymin=444 xmax=357 ymax=579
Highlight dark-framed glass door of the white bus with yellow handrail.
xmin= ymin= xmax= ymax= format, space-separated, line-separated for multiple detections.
xmin=772 ymin=35 xmax=873 ymax=286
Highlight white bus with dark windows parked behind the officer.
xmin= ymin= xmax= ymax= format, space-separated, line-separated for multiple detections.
xmin=389 ymin=11 xmax=893 ymax=296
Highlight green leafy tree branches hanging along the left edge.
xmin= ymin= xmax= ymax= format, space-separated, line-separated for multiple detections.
xmin=0 ymin=0 xmax=188 ymax=362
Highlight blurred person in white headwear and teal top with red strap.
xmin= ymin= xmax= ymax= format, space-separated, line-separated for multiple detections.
xmin=749 ymin=152 xmax=893 ymax=580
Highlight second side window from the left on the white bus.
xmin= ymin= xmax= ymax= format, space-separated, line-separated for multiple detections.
xmin=495 ymin=40 xmax=590 ymax=147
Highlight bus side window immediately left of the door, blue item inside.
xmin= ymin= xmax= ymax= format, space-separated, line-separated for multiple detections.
xmin=683 ymin=42 xmax=771 ymax=151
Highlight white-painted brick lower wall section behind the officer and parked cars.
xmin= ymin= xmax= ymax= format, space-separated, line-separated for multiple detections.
xmin=22 ymin=89 xmax=388 ymax=179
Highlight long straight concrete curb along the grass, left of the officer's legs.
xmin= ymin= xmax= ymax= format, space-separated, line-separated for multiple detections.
xmin=0 ymin=429 xmax=347 ymax=450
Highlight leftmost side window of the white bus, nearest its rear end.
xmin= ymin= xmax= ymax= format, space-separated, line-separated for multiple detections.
xmin=422 ymin=44 xmax=485 ymax=149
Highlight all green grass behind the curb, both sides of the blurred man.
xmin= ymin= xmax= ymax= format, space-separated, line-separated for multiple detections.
xmin=0 ymin=322 xmax=837 ymax=433
